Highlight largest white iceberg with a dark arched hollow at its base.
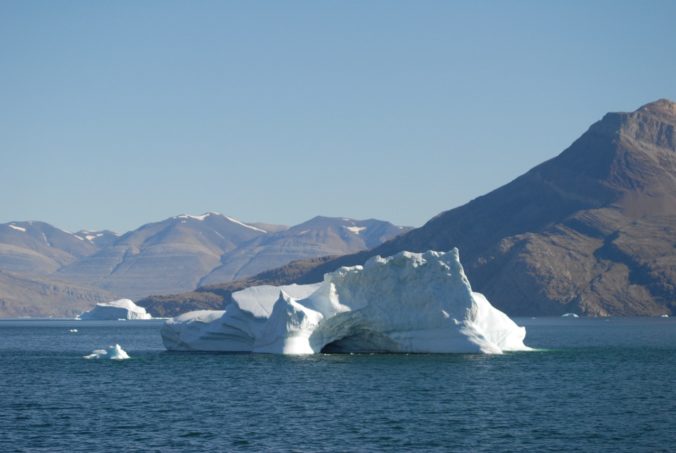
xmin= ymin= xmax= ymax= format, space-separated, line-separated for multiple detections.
xmin=161 ymin=249 xmax=530 ymax=354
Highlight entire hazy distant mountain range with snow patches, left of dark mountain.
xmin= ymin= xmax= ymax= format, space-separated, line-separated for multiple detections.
xmin=0 ymin=213 xmax=408 ymax=317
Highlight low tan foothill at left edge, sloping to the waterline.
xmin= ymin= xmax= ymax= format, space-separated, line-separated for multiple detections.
xmin=0 ymin=270 xmax=114 ymax=318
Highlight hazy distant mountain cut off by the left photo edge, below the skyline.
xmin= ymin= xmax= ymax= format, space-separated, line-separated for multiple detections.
xmin=0 ymin=222 xmax=97 ymax=275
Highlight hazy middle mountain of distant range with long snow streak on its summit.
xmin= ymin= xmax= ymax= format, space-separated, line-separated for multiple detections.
xmin=56 ymin=213 xmax=267 ymax=299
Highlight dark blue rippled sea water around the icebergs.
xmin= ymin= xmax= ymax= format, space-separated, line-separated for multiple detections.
xmin=0 ymin=318 xmax=676 ymax=452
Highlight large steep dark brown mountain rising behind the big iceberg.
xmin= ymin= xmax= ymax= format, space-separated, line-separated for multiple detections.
xmin=156 ymin=99 xmax=676 ymax=315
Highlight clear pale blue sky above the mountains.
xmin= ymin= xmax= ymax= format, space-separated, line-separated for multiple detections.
xmin=0 ymin=0 xmax=676 ymax=232
